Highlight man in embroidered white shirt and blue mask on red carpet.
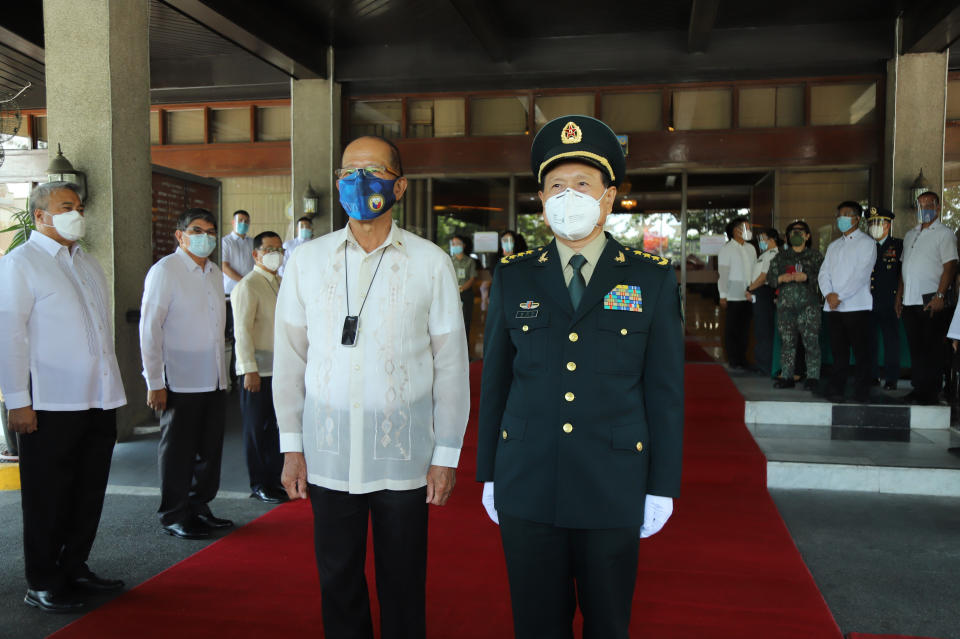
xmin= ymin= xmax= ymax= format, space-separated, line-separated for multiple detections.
xmin=273 ymin=137 xmax=470 ymax=638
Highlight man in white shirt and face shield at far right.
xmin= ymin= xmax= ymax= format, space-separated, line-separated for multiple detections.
xmin=897 ymin=191 xmax=957 ymax=404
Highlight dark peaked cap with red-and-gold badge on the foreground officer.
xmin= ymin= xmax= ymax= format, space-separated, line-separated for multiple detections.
xmin=530 ymin=115 xmax=627 ymax=186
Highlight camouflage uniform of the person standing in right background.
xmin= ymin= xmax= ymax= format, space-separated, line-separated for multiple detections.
xmin=767 ymin=247 xmax=823 ymax=380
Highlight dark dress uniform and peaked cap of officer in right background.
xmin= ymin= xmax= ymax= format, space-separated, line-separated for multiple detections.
xmin=869 ymin=207 xmax=903 ymax=390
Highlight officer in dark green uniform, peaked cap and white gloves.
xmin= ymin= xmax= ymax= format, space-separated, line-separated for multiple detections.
xmin=477 ymin=115 xmax=683 ymax=639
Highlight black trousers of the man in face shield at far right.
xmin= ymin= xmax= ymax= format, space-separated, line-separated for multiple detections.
xmin=902 ymin=305 xmax=953 ymax=399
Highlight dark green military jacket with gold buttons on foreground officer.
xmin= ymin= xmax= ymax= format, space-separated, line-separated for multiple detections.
xmin=477 ymin=235 xmax=684 ymax=528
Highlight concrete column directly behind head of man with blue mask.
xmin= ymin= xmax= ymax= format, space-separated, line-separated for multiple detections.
xmin=290 ymin=48 xmax=344 ymax=235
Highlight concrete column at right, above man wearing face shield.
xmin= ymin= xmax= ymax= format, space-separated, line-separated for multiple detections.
xmin=883 ymin=53 xmax=949 ymax=237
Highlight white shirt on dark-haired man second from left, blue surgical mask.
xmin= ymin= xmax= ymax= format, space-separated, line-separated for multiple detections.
xmin=140 ymin=248 xmax=227 ymax=393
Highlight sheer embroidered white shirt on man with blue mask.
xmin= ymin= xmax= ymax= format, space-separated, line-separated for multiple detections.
xmin=273 ymin=224 xmax=470 ymax=493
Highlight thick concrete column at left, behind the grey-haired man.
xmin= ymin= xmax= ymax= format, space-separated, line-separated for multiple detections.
xmin=43 ymin=0 xmax=151 ymax=439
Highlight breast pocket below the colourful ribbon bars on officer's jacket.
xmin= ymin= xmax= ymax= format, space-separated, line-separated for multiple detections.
xmin=596 ymin=310 xmax=650 ymax=375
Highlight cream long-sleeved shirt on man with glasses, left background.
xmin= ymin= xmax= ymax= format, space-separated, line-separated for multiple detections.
xmin=230 ymin=266 xmax=280 ymax=377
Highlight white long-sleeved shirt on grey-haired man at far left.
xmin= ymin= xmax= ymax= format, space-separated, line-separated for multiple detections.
xmin=0 ymin=231 xmax=127 ymax=411
